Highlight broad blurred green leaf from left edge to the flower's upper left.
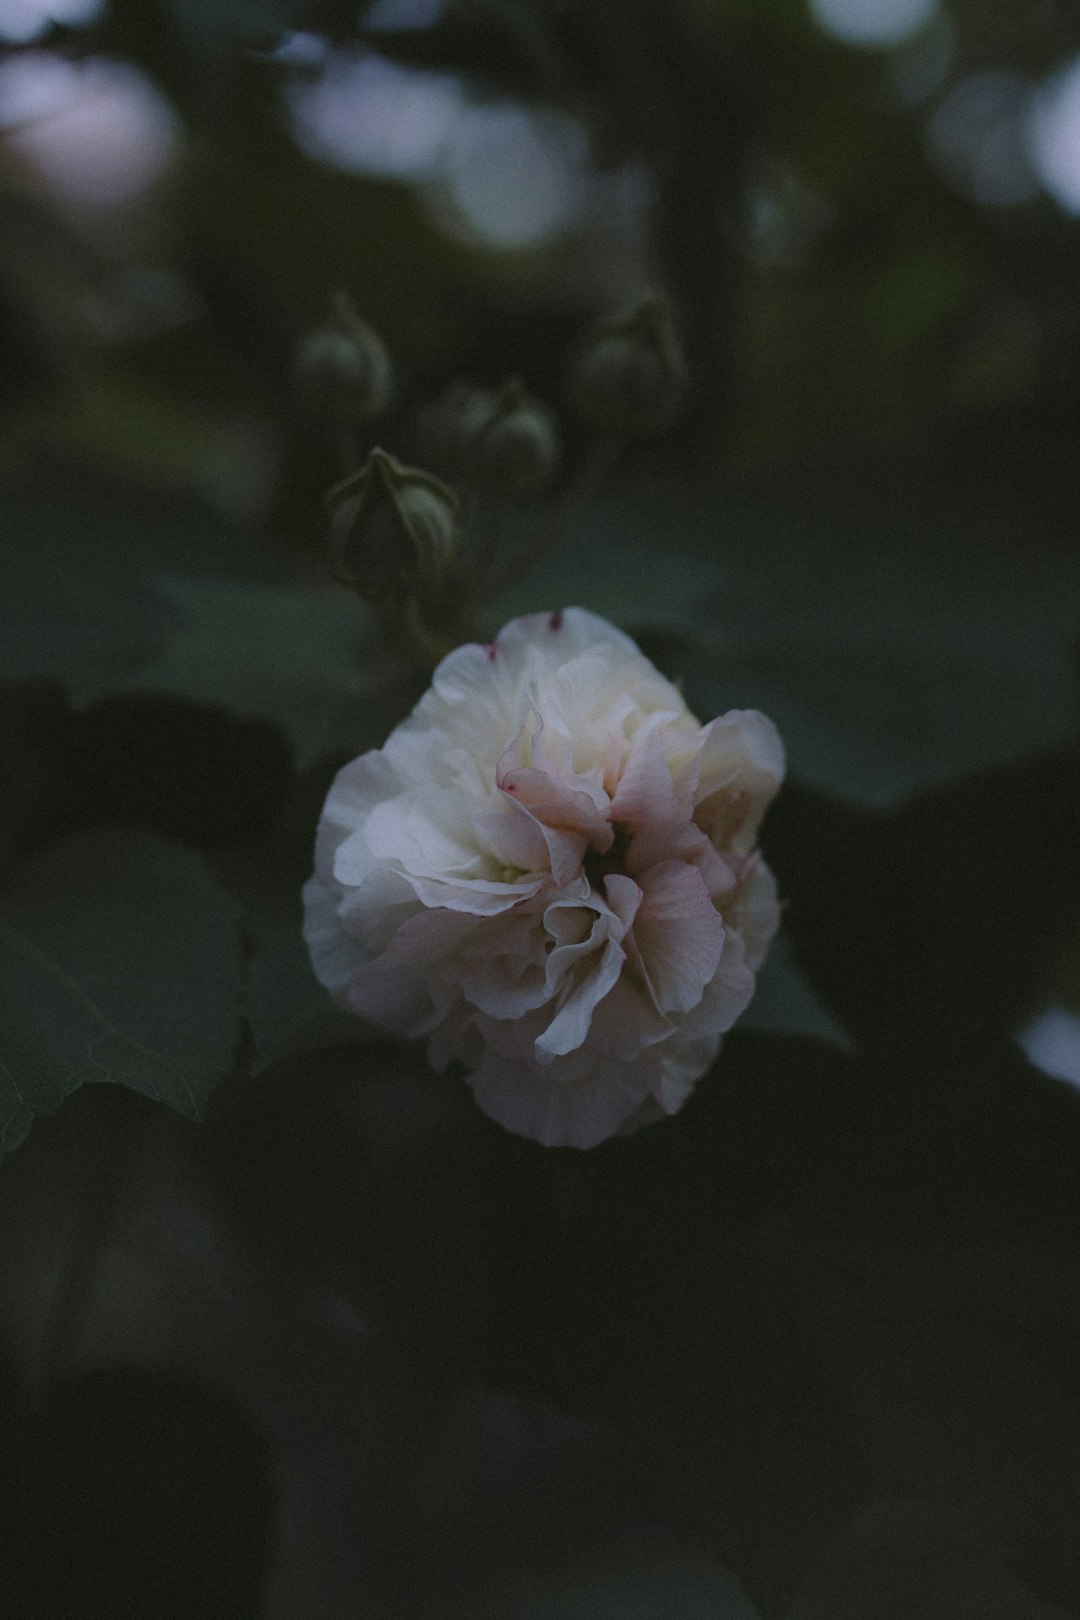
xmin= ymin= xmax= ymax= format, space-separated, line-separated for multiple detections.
xmin=0 ymin=467 xmax=419 ymax=767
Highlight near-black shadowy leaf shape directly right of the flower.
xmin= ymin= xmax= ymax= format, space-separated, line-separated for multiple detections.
xmin=763 ymin=750 xmax=1080 ymax=1058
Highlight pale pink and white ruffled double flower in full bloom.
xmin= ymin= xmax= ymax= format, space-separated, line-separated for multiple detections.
xmin=304 ymin=608 xmax=784 ymax=1147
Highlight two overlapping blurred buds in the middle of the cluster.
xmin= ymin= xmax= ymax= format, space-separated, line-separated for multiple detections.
xmin=421 ymin=382 xmax=560 ymax=496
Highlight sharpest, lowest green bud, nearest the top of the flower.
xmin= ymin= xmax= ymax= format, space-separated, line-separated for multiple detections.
xmin=327 ymin=450 xmax=458 ymax=601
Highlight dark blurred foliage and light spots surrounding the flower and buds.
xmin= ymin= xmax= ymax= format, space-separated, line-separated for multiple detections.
xmin=0 ymin=0 xmax=1080 ymax=1620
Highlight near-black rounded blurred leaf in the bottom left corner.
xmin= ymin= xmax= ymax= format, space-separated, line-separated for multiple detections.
xmin=6 ymin=1367 xmax=275 ymax=1620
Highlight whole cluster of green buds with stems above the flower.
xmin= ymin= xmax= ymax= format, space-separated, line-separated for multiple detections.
xmin=296 ymin=295 xmax=687 ymax=651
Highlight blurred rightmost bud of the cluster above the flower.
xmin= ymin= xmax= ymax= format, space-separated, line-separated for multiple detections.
xmin=568 ymin=298 xmax=687 ymax=437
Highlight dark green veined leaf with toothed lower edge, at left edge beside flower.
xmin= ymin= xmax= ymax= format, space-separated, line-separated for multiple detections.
xmin=0 ymin=828 xmax=241 ymax=1147
